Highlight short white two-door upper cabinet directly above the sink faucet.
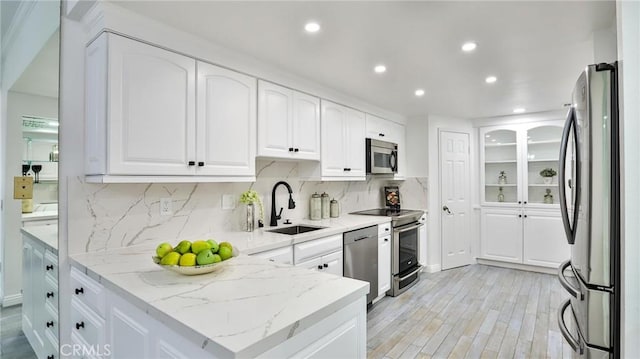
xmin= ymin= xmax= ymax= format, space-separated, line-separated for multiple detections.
xmin=258 ymin=81 xmax=320 ymax=160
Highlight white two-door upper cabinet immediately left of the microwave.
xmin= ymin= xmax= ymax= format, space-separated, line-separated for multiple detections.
xmin=322 ymin=100 xmax=366 ymax=180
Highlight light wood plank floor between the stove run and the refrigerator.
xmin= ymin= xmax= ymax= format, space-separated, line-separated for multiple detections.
xmin=367 ymin=264 xmax=572 ymax=358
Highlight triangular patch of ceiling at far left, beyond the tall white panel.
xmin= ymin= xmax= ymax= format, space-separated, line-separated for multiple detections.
xmin=11 ymin=31 xmax=60 ymax=98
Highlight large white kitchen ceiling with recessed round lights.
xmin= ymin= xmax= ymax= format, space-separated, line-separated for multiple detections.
xmin=118 ymin=1 xmax=615 ymax=118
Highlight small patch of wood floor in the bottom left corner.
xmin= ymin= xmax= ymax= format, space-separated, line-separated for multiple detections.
xmin=0 ymin=305 xmax=36 ymax=359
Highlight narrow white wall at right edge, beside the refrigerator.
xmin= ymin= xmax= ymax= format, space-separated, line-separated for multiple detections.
xmin=617 ymin=1 xmax=640 ymax=358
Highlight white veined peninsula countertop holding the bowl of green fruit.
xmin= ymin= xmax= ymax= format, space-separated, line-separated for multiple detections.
xmin=70 ymin=243 xmax=369 ymax=358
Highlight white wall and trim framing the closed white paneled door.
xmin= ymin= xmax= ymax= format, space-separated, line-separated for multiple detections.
xmin=427 ymin=115 xmax=480 ymax=272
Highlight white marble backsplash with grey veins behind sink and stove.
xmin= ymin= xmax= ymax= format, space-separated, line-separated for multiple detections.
xmin=68 ymin=160 xmax=428 ymax=254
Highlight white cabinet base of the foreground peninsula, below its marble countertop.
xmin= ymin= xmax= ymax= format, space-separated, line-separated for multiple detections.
xmin=70 ymin=262 xmax=366 ymax=359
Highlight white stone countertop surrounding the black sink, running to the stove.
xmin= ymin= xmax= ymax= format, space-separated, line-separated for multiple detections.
xmin=204 ymin=214 xmax=391 ymax=254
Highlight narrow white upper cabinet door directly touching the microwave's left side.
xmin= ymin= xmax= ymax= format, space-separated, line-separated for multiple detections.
xmin=343 ymin=109 xmax=366 ymax=177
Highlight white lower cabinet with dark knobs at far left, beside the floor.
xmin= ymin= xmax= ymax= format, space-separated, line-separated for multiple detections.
xmin=22 ymin=236 xmax=58 ymax=359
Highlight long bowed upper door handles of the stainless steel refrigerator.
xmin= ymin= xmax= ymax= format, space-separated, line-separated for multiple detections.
xmin=558 ymin=107 xmax=579 ymax=244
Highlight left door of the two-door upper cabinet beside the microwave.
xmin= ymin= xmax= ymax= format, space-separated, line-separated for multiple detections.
xmin=321 ymin=101 xmax=348 ymax=177
